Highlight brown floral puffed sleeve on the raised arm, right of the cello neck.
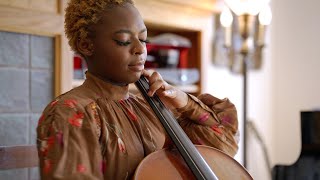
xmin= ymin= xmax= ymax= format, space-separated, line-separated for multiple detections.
xmin=177 ymin=94 xmax=239 ymax=157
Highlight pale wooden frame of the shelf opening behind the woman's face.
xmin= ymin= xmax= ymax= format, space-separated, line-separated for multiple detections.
xmin=131 ymin=0 xmax=216 ymax=95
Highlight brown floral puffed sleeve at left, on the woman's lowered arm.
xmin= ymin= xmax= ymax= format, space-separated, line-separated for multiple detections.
xmin=37 ymin=99 xmax=103 ymax=180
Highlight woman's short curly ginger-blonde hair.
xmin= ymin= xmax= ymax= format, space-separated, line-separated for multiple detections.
xmin=64 ymin=0 xmax=134 ymax=53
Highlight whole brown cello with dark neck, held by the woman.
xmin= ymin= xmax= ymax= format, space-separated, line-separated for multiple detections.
xmin=133 ymin=76 xmax=253 ymax=180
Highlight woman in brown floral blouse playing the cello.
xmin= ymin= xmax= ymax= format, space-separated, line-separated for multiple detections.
xmin=37 ymin=0 xmax=238 ymax=179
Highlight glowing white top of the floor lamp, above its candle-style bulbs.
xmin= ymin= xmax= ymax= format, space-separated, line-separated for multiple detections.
xmin=225 ymin=0 xmax=270 ymax=15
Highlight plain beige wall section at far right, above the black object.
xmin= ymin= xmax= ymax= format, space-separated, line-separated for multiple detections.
xmin=271 ymin=0 xmax=320 ymax=164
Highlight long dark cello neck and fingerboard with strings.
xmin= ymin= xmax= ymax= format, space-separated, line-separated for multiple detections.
xmin=135 ymin=76 xmax=218 ymax=180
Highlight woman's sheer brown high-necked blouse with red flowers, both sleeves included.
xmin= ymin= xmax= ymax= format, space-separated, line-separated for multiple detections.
xmin=37 ymin=73 xmax=238 ymax=180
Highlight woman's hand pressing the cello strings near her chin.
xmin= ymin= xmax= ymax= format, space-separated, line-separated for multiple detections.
xmin=143 ymin=70 xmax=188 ymax=109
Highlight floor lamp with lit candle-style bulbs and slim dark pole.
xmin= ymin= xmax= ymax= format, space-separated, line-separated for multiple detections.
xmin=220 ymin=0 xmax=272 ymax=167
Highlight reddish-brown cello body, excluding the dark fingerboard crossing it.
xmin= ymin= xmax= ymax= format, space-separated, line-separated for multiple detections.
xmin=133 ymin=145 xmax=253 ymax=180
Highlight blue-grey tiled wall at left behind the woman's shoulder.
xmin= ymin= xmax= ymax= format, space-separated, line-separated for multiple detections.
xmin=0 ymin=31 xmax=54 ymax=180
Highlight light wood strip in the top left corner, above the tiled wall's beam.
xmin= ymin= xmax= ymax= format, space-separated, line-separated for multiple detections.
xmin=0 ymin=0 xmax=59 ymax=13
